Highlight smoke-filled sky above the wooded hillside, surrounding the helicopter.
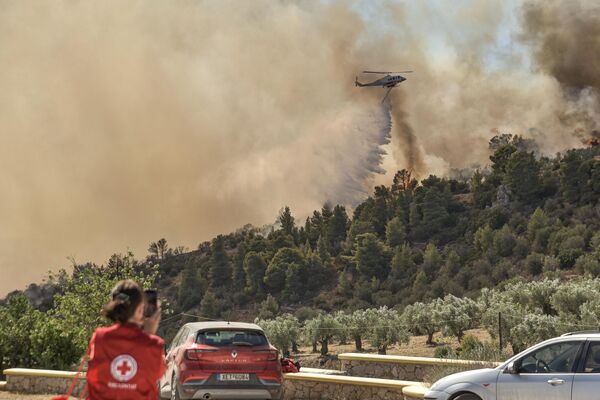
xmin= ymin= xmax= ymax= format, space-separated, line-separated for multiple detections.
xmin=0 ymin=0 xmax=600 ymax=294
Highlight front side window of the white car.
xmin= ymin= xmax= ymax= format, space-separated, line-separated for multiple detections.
xmin=519 ymin=341 xmax=582 ymax=374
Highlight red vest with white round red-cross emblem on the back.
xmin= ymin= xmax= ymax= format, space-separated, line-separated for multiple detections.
xmin=87 ymin=324 xmax=165 ymax=400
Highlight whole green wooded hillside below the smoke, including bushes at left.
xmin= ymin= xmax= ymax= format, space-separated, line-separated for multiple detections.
xmin=0 ymin=135 xmax=600 ymax=368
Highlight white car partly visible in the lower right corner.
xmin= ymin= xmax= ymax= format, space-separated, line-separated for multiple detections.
xmin=424 ymin=331 xmax=600 ymax=400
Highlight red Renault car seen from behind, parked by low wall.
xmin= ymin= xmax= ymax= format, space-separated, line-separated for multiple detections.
xmin=159 ymin=321 xmax=283 ymax=400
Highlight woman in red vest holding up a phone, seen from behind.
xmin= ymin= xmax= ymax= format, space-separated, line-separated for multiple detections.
xmin=87 ymin=280 xmax=165 ymax=400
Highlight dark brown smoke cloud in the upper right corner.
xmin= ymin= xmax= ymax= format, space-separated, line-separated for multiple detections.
xmin=521 ymin=0 xmax=600 ymax=142
